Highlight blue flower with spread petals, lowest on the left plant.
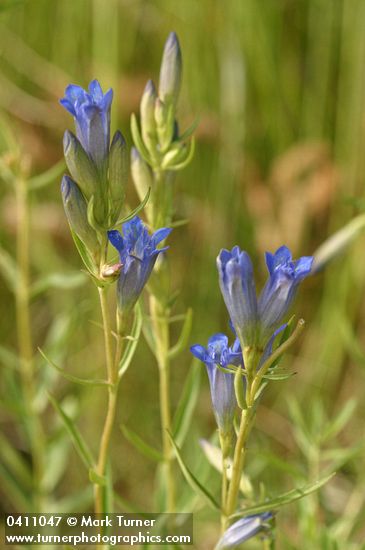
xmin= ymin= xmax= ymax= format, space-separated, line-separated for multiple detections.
xmin=108 ymin=216 xmax=171 ymax=313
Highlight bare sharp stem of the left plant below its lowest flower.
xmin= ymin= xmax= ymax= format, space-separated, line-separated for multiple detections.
xmin=94 ymin=287 xmax=118 ymax=514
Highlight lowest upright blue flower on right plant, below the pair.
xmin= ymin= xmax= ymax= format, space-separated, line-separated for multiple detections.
xmin=190 ymin=333 xmax=243 ymax=433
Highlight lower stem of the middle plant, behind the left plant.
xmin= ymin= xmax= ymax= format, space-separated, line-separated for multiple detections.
xmin=150 ymin=296 xmax=175 ymax=513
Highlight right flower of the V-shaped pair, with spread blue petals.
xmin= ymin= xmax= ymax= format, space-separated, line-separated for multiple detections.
xmin=258 ymin=246 xmax=313 ymax=335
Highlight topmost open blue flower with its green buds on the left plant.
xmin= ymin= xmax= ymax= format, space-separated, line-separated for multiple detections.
xmin=60 ymin=80 xmax=128 ymax=263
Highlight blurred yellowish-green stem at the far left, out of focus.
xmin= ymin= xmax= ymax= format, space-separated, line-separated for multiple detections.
xmin=16 ymin=175 xmax=44 ymax=512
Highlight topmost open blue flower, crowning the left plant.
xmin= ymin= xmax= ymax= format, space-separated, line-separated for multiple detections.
xmin=60 ymin=80 xmax=113 ymax=172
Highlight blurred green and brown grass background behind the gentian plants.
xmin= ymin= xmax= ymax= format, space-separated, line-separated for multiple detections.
xmin=0 ymin=0 xmax=365 ymax=548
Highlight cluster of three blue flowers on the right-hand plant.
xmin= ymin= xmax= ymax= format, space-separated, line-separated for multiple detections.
xmin=190 ymin=246 xmax=313 ymax=433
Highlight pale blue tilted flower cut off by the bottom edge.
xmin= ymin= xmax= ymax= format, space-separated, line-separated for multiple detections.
xmin=215 ymin=512 xmax=273 ymax=550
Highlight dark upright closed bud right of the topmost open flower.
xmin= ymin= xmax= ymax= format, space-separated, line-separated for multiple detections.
xmin=109 ymin=131 xmax=129 ymax=221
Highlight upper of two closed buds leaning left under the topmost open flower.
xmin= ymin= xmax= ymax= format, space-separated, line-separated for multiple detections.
xmin=63 ymin=130 xmax=98 ymax=198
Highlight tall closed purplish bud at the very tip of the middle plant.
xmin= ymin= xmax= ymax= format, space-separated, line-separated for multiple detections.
xmin=158 ymin=32 xmax=182 ymax=105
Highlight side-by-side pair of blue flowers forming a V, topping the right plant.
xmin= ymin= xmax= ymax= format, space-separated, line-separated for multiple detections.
xmin=217 ymin=246 xmax=313 ymax=348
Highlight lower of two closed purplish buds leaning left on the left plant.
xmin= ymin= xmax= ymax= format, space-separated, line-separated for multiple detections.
xmin=61 ymin=176 xmax=100 ymax=256
